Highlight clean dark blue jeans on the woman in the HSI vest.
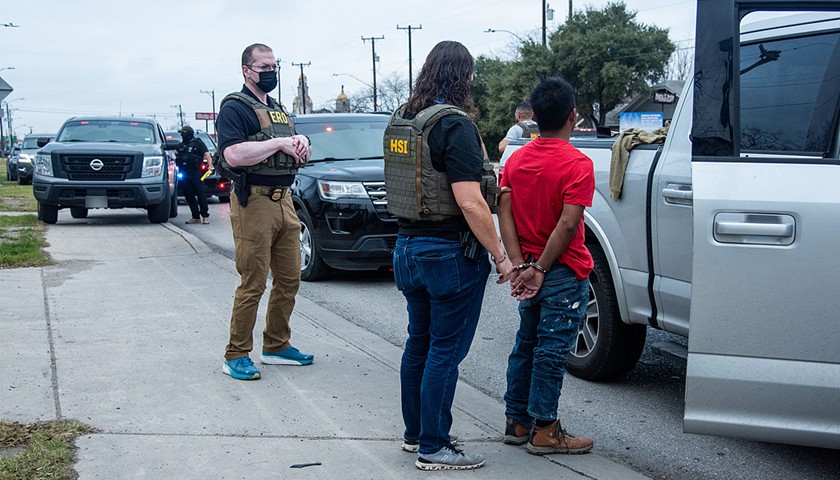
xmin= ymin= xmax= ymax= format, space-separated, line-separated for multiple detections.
xmin=394 ymin=236 xmax=490 ymax=453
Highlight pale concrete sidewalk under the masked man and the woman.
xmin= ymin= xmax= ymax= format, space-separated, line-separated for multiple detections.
xmin=0 ymin=212 xmax=646 ymax=480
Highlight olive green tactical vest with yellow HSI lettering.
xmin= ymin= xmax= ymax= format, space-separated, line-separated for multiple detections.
xmin=384 ymin=104 xmax=499 ymax=221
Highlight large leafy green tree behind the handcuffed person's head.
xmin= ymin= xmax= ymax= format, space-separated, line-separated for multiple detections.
xmin=548 ymin=3 xmax=676 ymax=125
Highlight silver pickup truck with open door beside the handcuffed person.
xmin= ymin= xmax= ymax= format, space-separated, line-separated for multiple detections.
xmin=502 ymin=0 xmax=840 ymax=448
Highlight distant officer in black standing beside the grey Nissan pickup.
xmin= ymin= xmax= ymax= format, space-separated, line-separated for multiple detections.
xmin=175 ymin=125 xmax=213 ymax=223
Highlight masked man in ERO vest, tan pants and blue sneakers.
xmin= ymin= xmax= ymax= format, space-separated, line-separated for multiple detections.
xmin=216 ymin=43 xmax=314 ymax=380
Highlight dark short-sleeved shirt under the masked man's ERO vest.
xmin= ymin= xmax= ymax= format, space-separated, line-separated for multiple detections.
xmin=216 ymin=86 xmax=295 ymax=187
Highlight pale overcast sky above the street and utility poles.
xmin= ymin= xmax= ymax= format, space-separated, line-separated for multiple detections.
xmin=0 ymin=0 xmax=696 ymax=135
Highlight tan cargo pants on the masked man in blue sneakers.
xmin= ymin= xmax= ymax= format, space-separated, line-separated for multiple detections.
xmin=225 ymin=191 xmax=300 ymax=360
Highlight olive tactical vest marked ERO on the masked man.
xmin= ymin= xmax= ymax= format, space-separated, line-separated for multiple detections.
xmin=219 ymin=92 xmax=298 ymax=176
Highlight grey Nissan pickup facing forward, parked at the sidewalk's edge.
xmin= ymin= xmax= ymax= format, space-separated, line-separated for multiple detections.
xmin=32 ymin=117 xmax=178 ymax=223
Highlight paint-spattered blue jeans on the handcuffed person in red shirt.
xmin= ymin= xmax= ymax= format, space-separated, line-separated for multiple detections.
xmin=505 ymin=265 xmax=589 ymax=425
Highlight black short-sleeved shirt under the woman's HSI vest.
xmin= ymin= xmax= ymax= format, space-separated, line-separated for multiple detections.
xmin=398 ymin=115 xmax=484 ymax=240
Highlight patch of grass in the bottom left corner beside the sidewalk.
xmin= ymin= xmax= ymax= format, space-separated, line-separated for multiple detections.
xmin=0 ymin=420 xmax=96 ymax=480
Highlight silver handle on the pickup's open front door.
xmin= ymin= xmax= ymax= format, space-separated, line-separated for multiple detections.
xmin=714 ymin=213 xmax=796 ymax=245
